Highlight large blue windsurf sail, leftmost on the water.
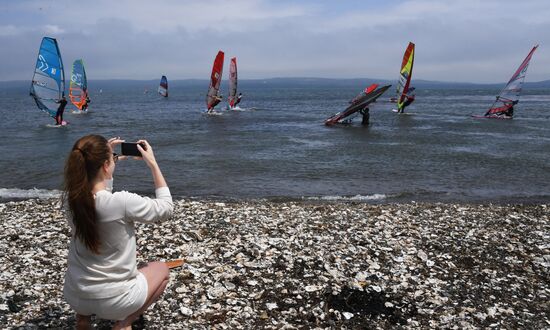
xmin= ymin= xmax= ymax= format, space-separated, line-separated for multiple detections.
xmin=30 ymin=37 xmax=65 ymax=118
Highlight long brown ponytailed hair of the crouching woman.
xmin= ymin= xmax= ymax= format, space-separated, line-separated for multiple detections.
xmin=64 ymin=135 xmax=111 ymax=253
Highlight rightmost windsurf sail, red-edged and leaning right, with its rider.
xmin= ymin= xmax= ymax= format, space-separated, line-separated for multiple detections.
xmin=484 ymin=45 xmax=539 ymax=118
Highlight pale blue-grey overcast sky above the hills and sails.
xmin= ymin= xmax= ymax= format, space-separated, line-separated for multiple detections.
xmin=0 ymin=0 xmax=550 ymax=83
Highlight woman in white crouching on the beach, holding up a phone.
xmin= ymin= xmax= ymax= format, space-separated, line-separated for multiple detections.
xmin=63 ymin=135 xmax=173 ymax=329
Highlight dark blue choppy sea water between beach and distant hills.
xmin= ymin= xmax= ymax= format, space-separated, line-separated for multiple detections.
xmin=0 ymin=80 xmax=550 ymax=202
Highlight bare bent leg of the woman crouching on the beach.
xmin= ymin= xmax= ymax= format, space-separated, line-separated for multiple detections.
xmin=113 ymin=261 xmax=170 ymax=329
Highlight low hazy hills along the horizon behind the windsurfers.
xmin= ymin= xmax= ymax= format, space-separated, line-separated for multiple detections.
xmin=0 ymin=78 xmax=550 ymax=90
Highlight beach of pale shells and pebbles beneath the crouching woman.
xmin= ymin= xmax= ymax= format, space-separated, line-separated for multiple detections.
xmin=0 ymin=199 xmax=550 ymax=329
